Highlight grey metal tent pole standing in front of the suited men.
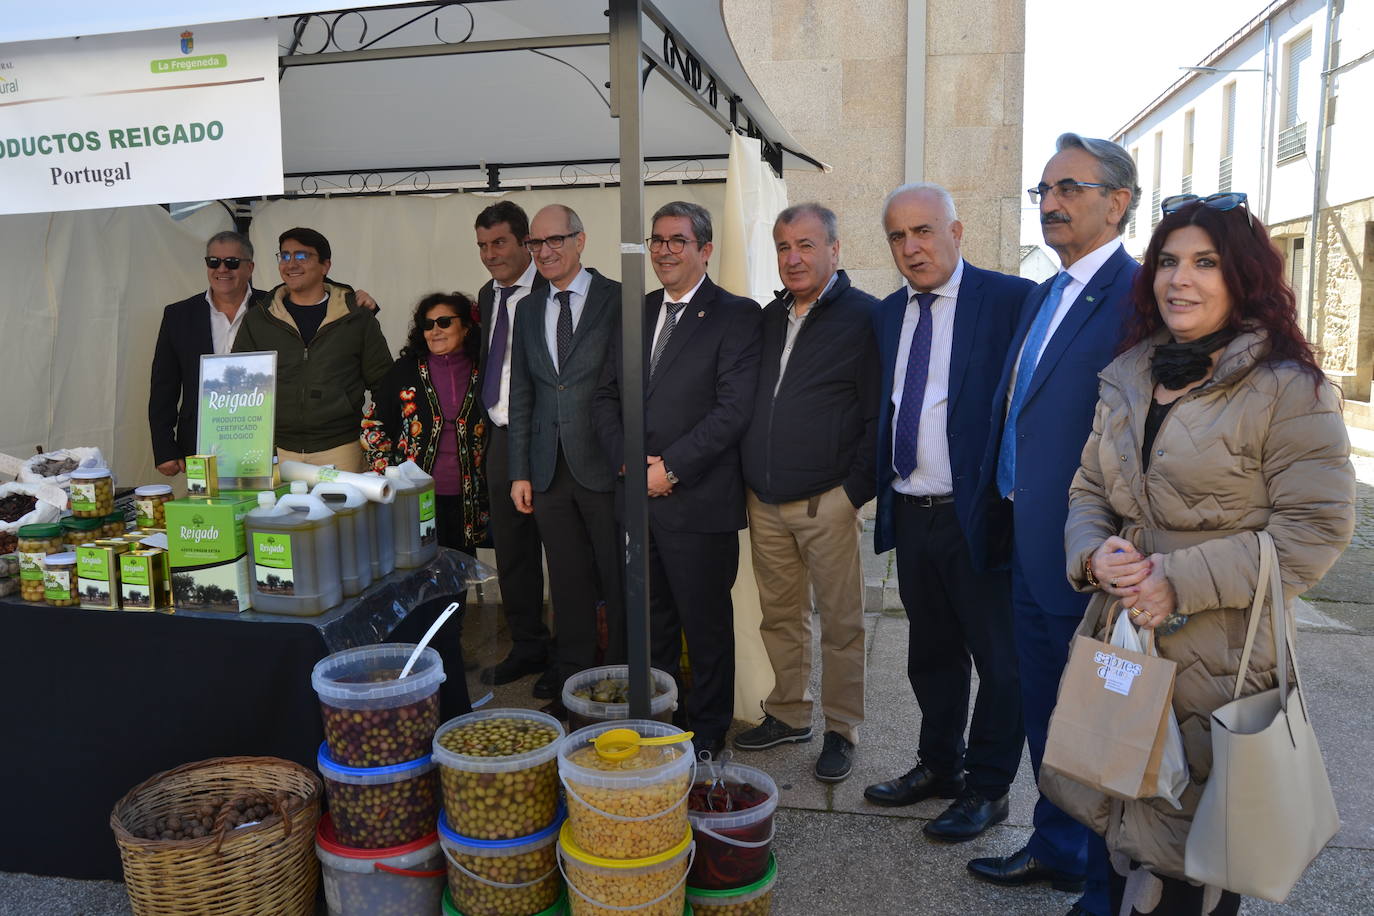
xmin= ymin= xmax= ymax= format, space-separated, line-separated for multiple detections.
xmin=610 ymin=0 xmax=650 ymax=718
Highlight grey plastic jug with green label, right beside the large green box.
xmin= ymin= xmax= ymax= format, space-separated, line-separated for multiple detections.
xmin=243 ymin=481 xmax=344 ymax=617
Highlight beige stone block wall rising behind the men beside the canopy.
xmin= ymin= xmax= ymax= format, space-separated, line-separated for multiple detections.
xmin=724 ymin=0 xmax=1025 ymax=297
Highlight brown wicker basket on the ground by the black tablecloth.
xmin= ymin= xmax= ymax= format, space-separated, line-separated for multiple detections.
xmin=110 ymin=757 xmax=322 ymax=916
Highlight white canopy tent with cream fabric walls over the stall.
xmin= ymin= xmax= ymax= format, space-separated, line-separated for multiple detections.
xmin=0 ymin=0 xmax=807 ymax=707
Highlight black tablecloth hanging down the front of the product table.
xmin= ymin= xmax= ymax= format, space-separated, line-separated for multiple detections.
xmin=0 ymin=552 xmax=489 ymax=879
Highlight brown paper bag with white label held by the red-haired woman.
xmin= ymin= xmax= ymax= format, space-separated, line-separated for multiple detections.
xmin=1040 ymin=609 xmax=1178 ymax=799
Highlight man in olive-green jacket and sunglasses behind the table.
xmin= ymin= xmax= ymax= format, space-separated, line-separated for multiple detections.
xmin=234 ymin=228 xmax=392 ymax=471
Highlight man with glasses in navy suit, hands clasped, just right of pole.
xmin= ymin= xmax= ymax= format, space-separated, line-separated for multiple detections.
xmin=595 ymin=201 xmax=761 ymax=757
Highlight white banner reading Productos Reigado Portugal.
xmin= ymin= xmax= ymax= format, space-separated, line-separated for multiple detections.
xmin=0 ymin=19 xmax=282 ymax=213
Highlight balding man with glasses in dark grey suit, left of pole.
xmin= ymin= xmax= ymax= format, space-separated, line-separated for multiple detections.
xmin=508 ymin=203 xmax=625 ymax=697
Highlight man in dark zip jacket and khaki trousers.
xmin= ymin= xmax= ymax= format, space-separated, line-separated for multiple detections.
xmin=735 ymin=203 xmax=878 ymax=783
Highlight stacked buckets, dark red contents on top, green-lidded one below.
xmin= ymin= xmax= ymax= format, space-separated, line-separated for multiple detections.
xmin=687 ymin=764 xmax=778 ymax=916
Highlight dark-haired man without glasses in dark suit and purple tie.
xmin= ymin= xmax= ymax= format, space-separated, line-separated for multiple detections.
xmin=474 ymin=201 xmax=562 ymax=699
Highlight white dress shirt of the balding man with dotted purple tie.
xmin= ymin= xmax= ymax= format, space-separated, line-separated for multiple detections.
xmin=888 ymin=258 xmax=963 ymax=496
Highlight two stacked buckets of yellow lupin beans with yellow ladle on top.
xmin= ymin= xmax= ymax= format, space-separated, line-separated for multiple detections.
xmin=558 ymin=720 xmax=694 ymax=916
